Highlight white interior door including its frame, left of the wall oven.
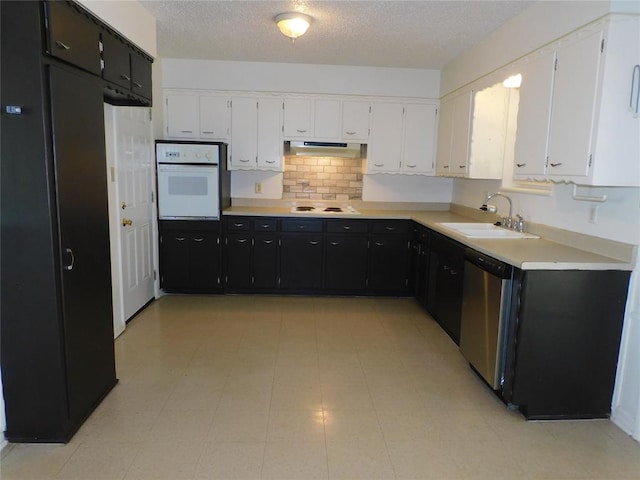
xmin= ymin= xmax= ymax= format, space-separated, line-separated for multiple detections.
xmin=105 ymin=105 xmax=155 ymax=337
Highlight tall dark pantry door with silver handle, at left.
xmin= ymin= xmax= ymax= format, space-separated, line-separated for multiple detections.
xmin=50 ymin=67 xmax=115 ymax=422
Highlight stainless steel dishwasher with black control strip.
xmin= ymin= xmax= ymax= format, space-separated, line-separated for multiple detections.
xmin=460 ymin=248 xmax=513 ymax=390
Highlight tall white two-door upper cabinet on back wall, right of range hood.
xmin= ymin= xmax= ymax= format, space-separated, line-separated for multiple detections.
xmin=367 ymin=102 xmax=437 ymax=175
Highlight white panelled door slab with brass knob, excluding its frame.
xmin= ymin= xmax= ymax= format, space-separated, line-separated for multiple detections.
xmin=115 ymin=107 xmax=155 ymax=321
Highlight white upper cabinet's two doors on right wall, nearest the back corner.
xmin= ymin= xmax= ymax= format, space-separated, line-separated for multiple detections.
xmin=436 ymin=90 xmax=473 ymax=177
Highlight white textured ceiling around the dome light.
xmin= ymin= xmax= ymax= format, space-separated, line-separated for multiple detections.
xmin=142 ymin=0 xmax=534 ymax=69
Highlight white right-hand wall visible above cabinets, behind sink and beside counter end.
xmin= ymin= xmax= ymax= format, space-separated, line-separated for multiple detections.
xmin=442 ymin=2 xmax=640 ymax=439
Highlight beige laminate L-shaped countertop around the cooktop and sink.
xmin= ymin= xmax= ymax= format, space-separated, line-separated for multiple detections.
xmin=223 ymin=206 xmax=633 ymax=271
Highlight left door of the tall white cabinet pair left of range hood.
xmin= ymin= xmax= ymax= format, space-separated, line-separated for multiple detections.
xmin=230 ymin=97 xmax=258 ymax=170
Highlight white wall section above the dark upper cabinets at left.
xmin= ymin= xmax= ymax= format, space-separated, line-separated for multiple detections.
xmin=78 ymin=0 xmax=158 ymax=57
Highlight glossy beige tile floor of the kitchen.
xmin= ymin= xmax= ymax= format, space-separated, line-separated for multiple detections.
xmin=0 ymin=296 xmax=640 ymax=480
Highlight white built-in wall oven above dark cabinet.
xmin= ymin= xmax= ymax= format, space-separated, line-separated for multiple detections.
xmin=156 ymin=141 xmax=226 ymax=220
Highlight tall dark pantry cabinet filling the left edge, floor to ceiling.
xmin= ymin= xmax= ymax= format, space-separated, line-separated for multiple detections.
xmin=0 ymin=1 xmax=150 ymax=442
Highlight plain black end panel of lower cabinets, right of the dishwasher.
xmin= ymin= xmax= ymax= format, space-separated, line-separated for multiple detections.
xmin=503 ymin=270 xmax=629 ymax=419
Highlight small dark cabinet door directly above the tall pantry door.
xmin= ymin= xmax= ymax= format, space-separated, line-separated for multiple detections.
xmin=44 ymin=1 xmax=104 ymax=76
